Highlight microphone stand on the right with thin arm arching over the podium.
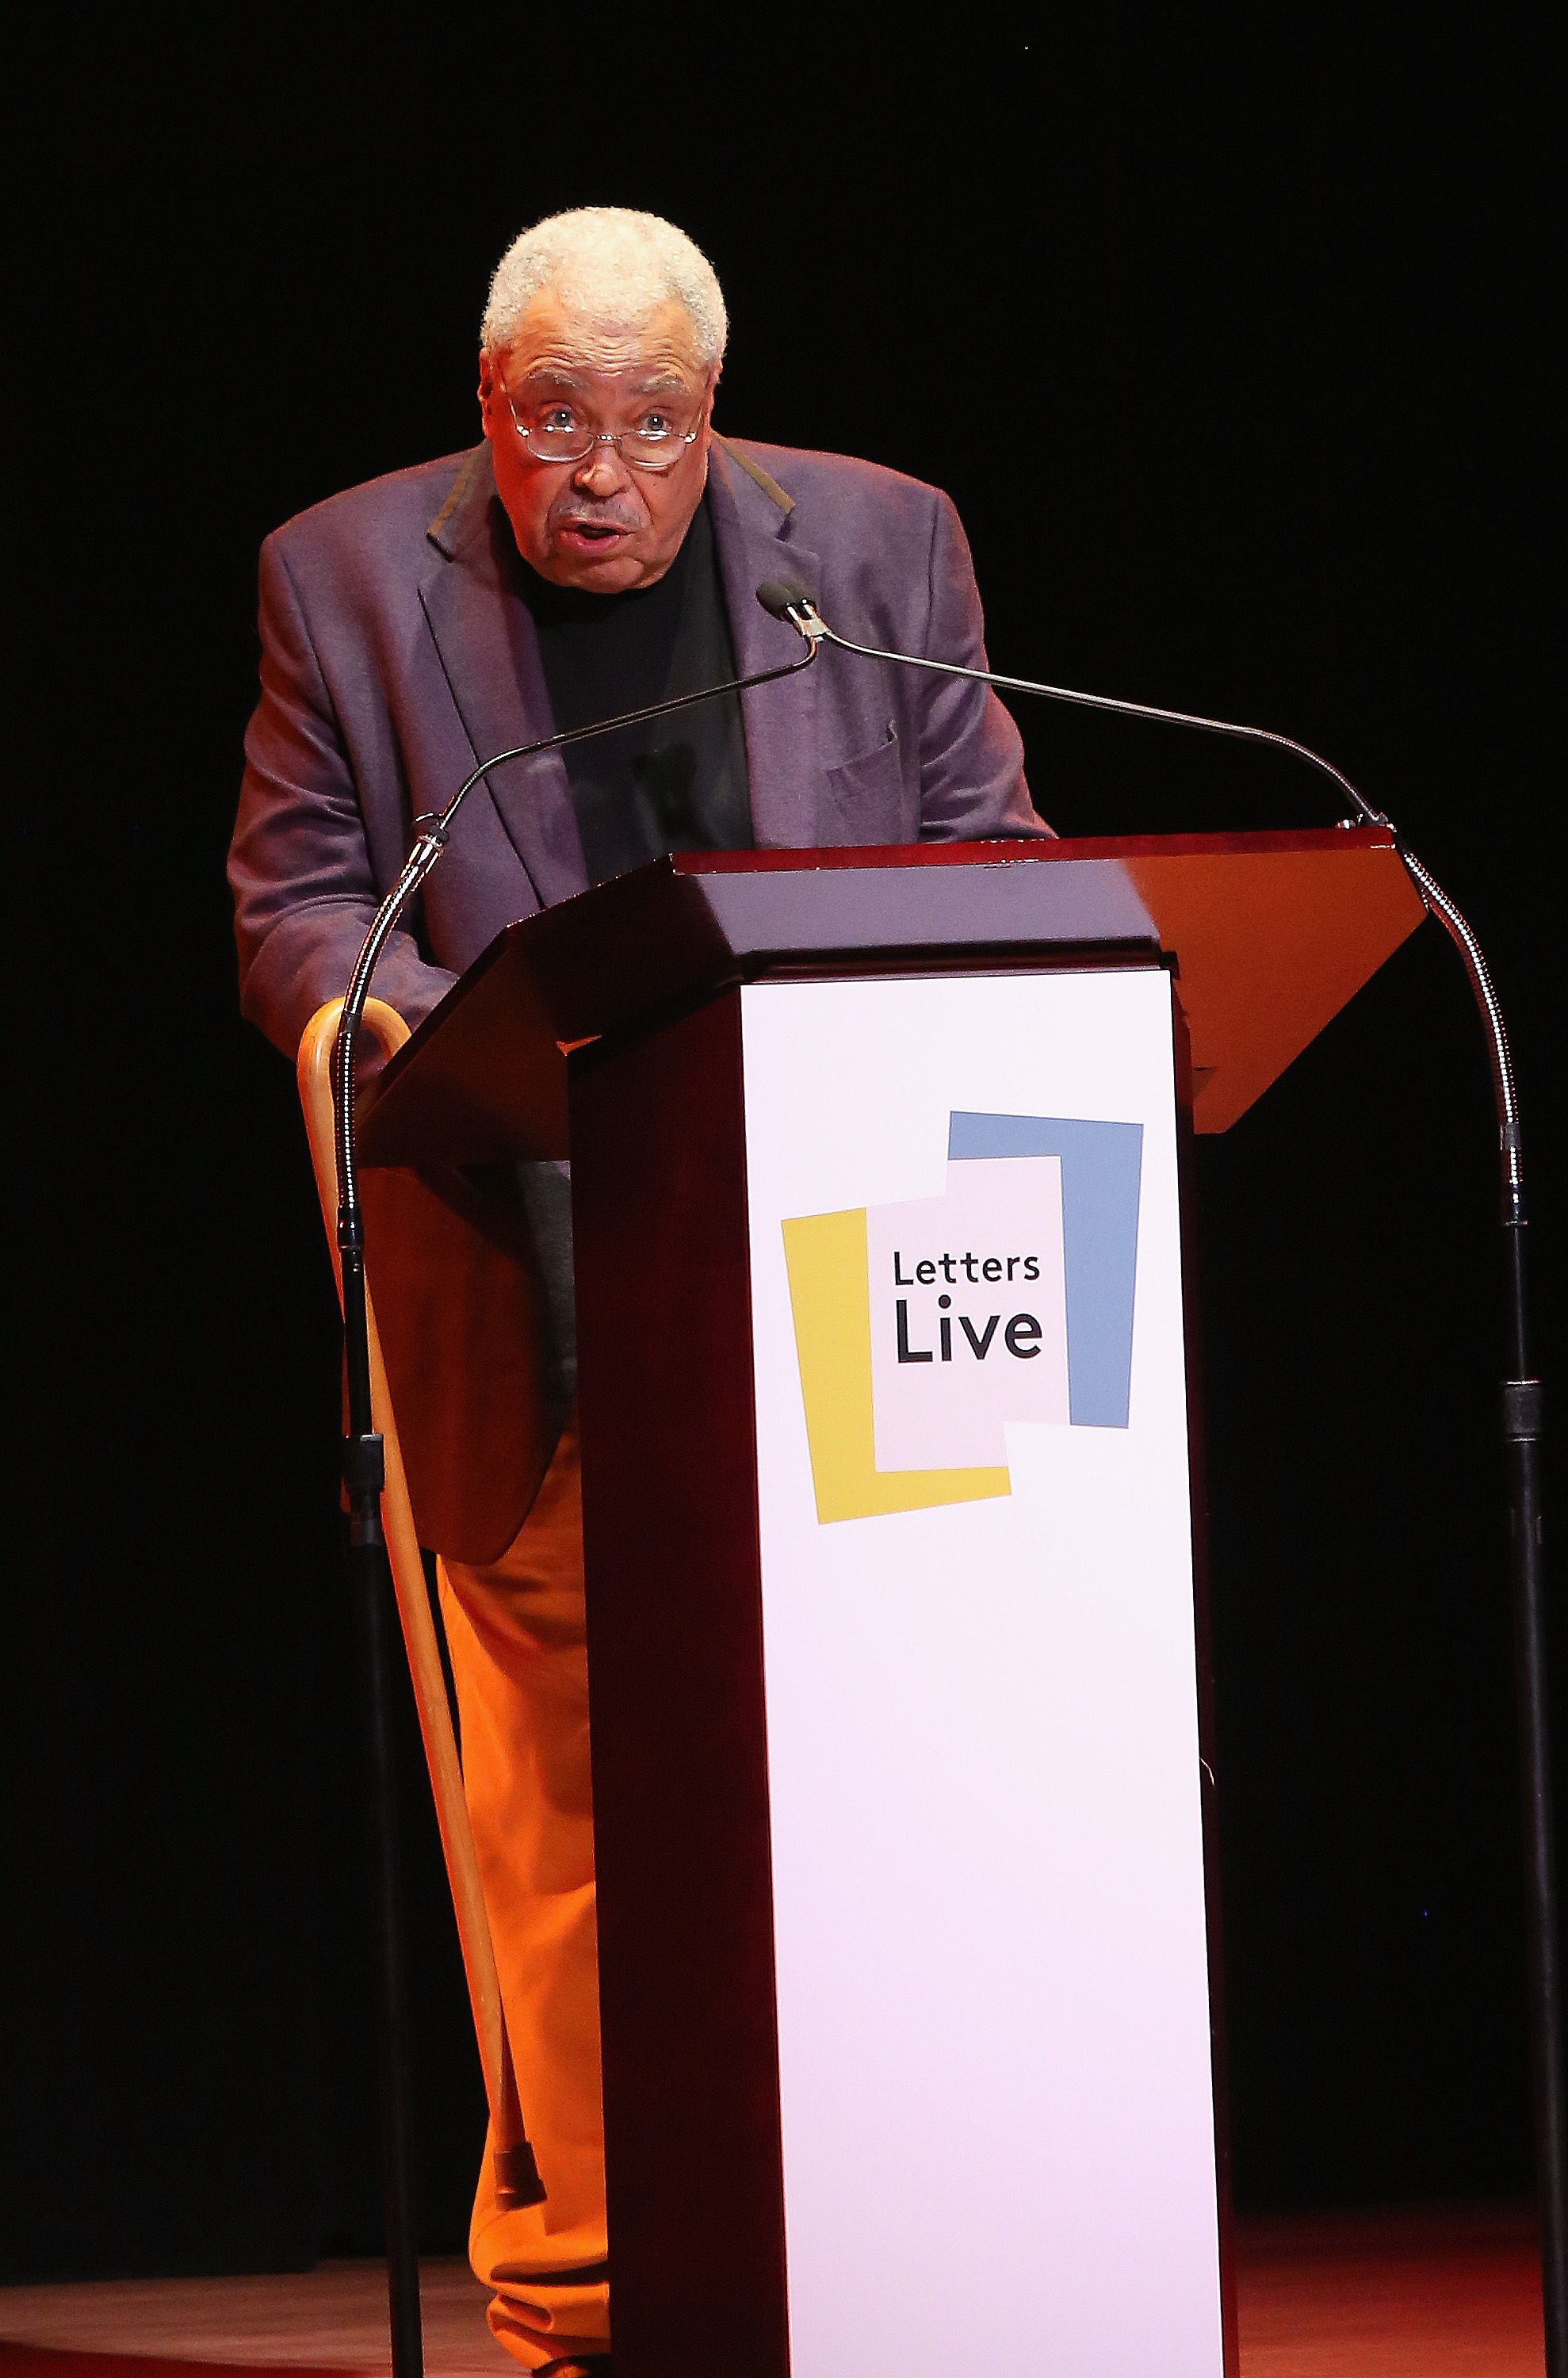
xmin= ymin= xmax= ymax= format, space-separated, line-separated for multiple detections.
xmin=756 ymin=580 xmax=1568 ymax=2378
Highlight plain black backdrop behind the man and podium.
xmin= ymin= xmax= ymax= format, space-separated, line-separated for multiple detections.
xmin=0 ymin=10 xmax=1568 ymax=2278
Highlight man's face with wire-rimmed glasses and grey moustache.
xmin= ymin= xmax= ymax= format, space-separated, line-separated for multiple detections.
xmin=478 ymin=290 xmax=718 ymax=594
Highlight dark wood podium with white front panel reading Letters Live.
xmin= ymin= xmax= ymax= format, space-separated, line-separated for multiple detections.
xmin=361 ymin=830 xmax=1425 ymax=2378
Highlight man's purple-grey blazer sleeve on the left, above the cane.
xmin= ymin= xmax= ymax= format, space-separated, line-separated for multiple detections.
xmin=228 ymin=537 xmax=454 ymax=1058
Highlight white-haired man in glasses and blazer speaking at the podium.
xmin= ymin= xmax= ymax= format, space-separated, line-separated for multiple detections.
xmin=231 ymin=207 xmax=1045 ymax=2373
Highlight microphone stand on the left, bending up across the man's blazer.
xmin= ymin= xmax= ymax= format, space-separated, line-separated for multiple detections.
xmin=333 ymin=635 xmax=817 ymax=2378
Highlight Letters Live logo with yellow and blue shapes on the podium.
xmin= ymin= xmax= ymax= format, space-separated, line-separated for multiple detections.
xmin=782 ymin=1113 xmax=1142 ymax=1520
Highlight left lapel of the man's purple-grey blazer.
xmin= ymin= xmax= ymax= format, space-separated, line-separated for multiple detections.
xmin=419 ymin=445 xmax=590 ymax=908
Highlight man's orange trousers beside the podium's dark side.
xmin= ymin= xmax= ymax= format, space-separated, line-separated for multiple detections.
xmin=438 ymin=1422 xmax=609 ymax=2368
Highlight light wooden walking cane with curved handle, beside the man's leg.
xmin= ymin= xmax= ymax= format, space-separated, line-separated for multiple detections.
xmin=297 ymin=999 xmax=545 ymax=2207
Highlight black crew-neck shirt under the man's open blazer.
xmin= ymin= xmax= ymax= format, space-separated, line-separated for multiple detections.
xmin=518 ymin=497 xmax=751 ymax=882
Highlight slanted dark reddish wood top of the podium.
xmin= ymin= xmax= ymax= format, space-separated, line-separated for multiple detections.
xmin=359 ymin=828 xmax=1425 ymax=1165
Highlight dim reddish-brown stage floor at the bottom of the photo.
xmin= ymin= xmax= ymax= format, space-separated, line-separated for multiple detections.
xmin=0 ymin=2207 xmax=1544 ymax=2378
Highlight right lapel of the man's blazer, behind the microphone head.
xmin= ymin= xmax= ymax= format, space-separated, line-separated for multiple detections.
xmin=706 ymin=440 xmax=821 ymax=849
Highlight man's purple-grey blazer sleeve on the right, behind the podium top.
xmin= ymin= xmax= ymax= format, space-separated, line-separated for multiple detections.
xmin=921 ymin=495 xmax=1052 ymax=842
